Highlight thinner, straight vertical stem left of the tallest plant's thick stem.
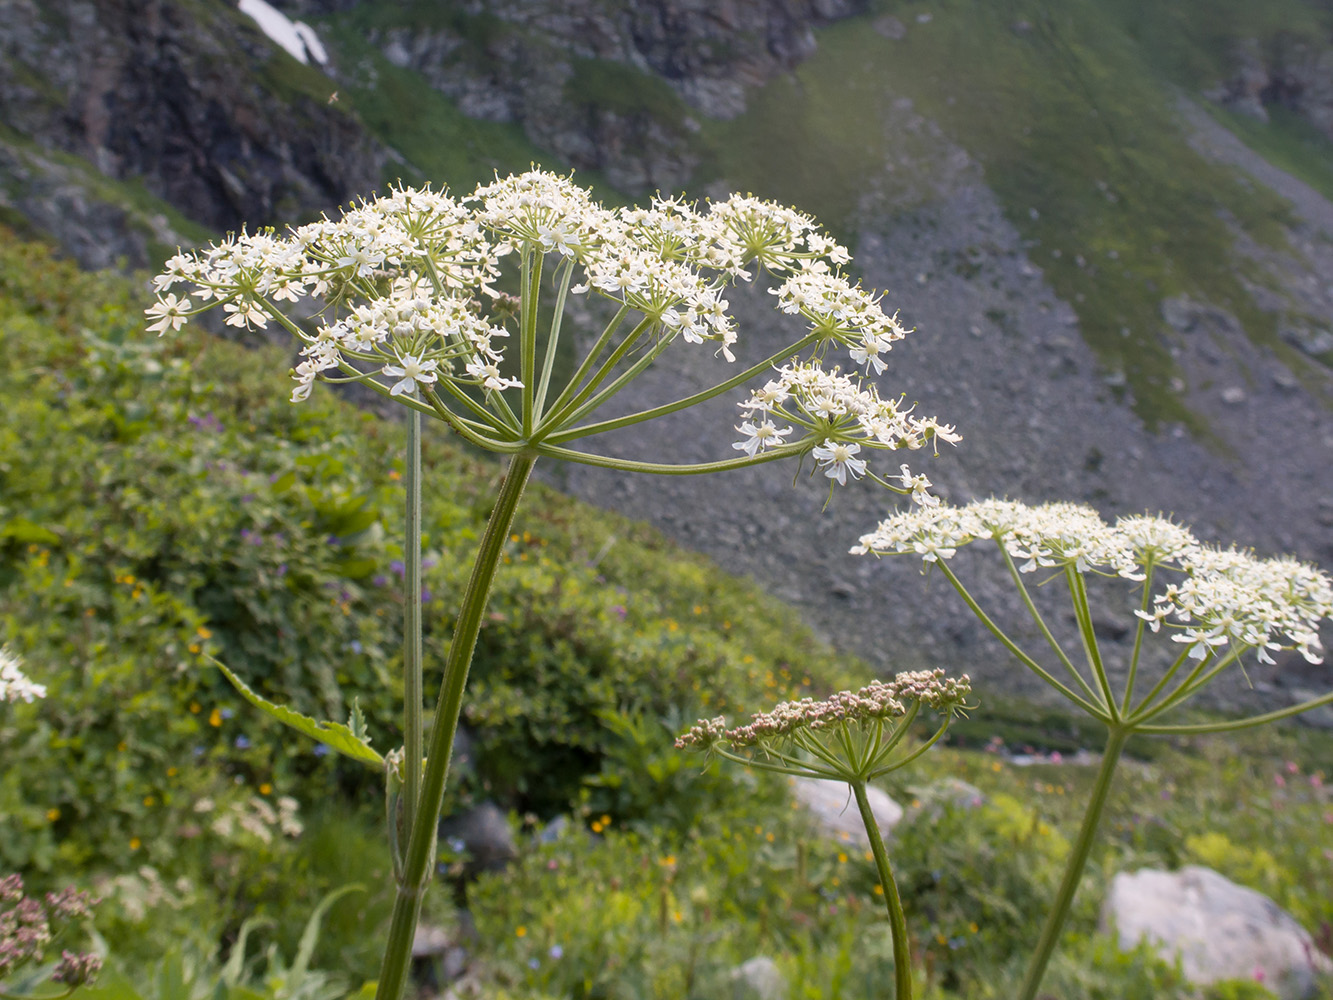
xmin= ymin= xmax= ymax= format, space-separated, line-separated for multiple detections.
xmin=389 ymin=409 xmax=423 ymax=829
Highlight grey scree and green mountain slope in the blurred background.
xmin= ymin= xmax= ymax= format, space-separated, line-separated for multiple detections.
xmin=0 ymin=0 xmax=1333 ymax=720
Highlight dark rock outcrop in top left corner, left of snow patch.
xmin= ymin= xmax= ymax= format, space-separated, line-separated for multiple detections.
xmin=0 ymin=0 xmax=388 ymax=265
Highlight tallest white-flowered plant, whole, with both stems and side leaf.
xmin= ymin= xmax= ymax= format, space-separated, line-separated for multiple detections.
xmin=148 ymin=169 xmax=957 ymax=1000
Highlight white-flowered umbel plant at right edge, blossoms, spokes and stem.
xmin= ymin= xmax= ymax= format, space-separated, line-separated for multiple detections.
xmin=852 ymin=500 xmax=1333 ymax=1000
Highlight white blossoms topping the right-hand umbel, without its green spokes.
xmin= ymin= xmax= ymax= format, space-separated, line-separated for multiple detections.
xmin=852 ymin=500 xmax=1333 ymax=663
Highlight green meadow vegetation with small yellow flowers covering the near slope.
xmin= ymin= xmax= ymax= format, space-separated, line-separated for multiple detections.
xmin=0 ymin=240 xmax=1333 ymax=1000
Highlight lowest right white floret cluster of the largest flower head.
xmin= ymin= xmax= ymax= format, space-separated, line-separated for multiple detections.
xmin=732 ymin=361 xmax=960 ymax=496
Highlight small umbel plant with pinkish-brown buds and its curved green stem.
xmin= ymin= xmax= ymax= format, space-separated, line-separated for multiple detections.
xmin=676 ymin=669 xmax=972 ymax=1000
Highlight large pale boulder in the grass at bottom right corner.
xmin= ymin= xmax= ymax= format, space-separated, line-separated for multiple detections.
xmin=1101 ymin=865 xmax=1333 ymax=1000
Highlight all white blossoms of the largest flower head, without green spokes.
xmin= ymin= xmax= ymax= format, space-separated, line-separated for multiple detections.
xmin=147 ymin=169 xmax=958 ymax=482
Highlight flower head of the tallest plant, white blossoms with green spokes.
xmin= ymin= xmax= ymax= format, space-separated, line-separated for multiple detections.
xmin=147 ymin=169 xmax=957 ymax=500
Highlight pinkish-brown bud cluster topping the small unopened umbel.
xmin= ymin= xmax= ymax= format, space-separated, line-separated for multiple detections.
xmin=676 ymin=669 xmax=972 ymax=749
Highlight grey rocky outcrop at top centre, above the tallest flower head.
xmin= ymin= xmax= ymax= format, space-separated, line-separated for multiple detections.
xmin=317 ymin=0 xmax=866 ymax=193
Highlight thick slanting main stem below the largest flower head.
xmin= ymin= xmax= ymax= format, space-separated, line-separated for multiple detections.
xmin=375 ymin=452 xmax=537 ymax=1000
